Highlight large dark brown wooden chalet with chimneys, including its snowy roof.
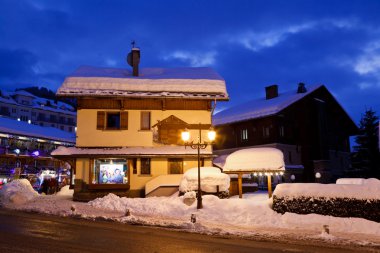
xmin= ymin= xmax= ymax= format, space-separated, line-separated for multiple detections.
xmin=213 ymin=83 xmax=357 ymax=182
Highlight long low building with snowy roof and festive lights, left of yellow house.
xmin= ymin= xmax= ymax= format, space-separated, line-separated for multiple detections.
xmin=0 ymin=117 xmax=75 ymax=177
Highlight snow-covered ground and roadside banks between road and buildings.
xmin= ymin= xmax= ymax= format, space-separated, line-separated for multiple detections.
xmin=0 ymin=179 xmax=380 ymax=248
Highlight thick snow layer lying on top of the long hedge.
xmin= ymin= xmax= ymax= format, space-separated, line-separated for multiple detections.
xmin=273 ymin=178 xmax=380 ymax=200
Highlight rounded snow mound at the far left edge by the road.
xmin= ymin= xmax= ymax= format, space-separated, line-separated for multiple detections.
xmin=0 ymin=179 xmax=38 ymax=206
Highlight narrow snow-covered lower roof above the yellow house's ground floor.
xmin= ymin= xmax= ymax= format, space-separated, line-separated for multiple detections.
xmin=51 ymin=145 xmax=212 ymax=156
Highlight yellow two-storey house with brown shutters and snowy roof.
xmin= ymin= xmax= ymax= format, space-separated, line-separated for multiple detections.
xmin=53 ymin=48 xmax=228 ymax=201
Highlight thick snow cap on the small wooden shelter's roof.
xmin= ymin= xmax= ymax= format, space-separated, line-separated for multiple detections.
xmin=223 ymin=148 xmax=285 ymax=172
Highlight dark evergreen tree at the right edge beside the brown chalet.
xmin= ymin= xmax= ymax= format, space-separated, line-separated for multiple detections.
xmin=354 ymin=109 xmax=380 ymax=178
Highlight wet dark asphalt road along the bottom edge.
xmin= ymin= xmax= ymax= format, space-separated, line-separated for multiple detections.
xmin=0 ymin=209 xmax=376 ymax=253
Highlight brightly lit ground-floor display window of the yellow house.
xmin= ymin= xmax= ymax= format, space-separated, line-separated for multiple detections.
xmin=92 ymin=159 xmax=128 ymax=184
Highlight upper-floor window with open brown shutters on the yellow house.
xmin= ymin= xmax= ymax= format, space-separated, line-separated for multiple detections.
xmin=96 ymin=111 xmax=128 ymax=130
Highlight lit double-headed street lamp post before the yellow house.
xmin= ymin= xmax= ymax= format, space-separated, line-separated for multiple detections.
xmin=181 ymin=123 xmax=216 ymax=209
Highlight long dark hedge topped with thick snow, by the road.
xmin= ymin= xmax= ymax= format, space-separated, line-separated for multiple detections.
xmin=273 ymin=179 xmax=380 ymax=222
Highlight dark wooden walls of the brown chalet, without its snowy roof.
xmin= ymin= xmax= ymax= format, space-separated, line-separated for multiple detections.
xmin=214 ymin=86 xmax=357 ymax=182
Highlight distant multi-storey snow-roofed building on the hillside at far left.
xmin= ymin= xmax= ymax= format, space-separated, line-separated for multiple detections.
xmin=0 ymin=90 xmax=76 ymax=133
